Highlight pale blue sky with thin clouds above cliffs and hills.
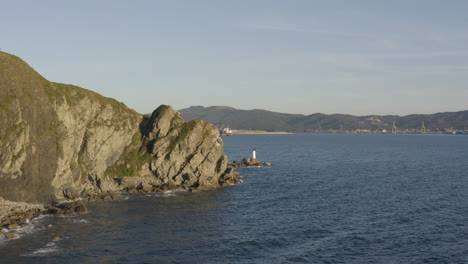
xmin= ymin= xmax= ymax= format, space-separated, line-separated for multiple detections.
xmin=0 ymin=0 xmax=468 ymax=115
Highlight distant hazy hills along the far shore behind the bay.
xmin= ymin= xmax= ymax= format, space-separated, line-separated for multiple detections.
xmin=179 ymin=106 xmax=468 ymax=133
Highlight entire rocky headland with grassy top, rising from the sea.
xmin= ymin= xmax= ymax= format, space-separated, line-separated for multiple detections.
xmin=0 ymin=52 xmax=239 ymax=203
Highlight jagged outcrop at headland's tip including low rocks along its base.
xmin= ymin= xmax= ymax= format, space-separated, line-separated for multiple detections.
xmin=104 ymin=105 xmax=239 ymax=192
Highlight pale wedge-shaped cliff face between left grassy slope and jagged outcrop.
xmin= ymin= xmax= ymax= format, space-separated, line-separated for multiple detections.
xmin=48 ymin=83 xmax=142 ymax=198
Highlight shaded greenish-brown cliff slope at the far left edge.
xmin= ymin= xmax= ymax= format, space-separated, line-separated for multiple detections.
xmin=0 ymin=53 xmax=60 ymax=201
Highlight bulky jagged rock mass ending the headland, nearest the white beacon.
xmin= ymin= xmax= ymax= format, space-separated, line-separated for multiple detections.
xmin=137 ymin=106 xmax=238 ymax=189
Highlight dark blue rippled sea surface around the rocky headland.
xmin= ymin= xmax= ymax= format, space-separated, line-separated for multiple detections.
xmin=0 ymin=134 xmax=468 ymax=263
